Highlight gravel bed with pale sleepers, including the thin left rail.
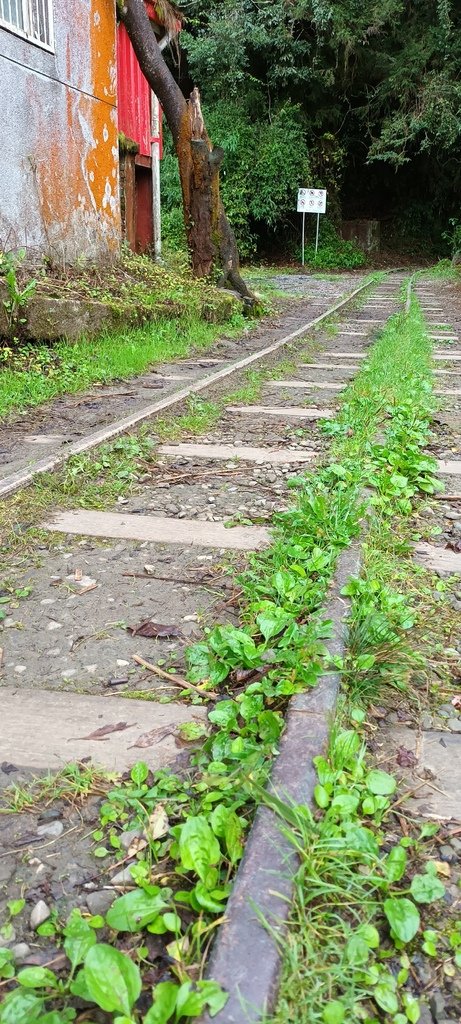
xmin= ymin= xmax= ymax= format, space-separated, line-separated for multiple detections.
xmin=2 ymin=273 xmax=404 ymax=745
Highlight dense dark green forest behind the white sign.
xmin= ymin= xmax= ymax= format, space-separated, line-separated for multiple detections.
xmin=159 ymin=0 xmax=461 ymax=257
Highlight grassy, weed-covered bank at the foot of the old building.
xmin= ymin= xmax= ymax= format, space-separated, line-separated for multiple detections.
xmin=0 ymin=252 xmax=245 ymax=418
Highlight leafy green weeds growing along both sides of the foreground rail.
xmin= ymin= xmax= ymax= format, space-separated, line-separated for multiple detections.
xmin=0 ymin=288 xmax=452 ymax=1024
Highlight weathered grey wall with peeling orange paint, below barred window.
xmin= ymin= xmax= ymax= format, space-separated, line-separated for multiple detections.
xmin=0 ymin=0 xmax=121 ymax=263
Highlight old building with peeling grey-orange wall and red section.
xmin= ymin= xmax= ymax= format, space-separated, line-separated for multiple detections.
xmin=0 ymin=0 xmax=163 ymax=264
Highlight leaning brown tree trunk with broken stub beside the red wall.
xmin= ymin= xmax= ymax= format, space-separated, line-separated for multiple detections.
xmin=115 ymin=0 xmax=253 ymax=299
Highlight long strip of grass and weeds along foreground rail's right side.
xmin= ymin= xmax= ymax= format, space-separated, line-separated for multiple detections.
xmin=271 ymin=292 xmax=461 ymax=1024
